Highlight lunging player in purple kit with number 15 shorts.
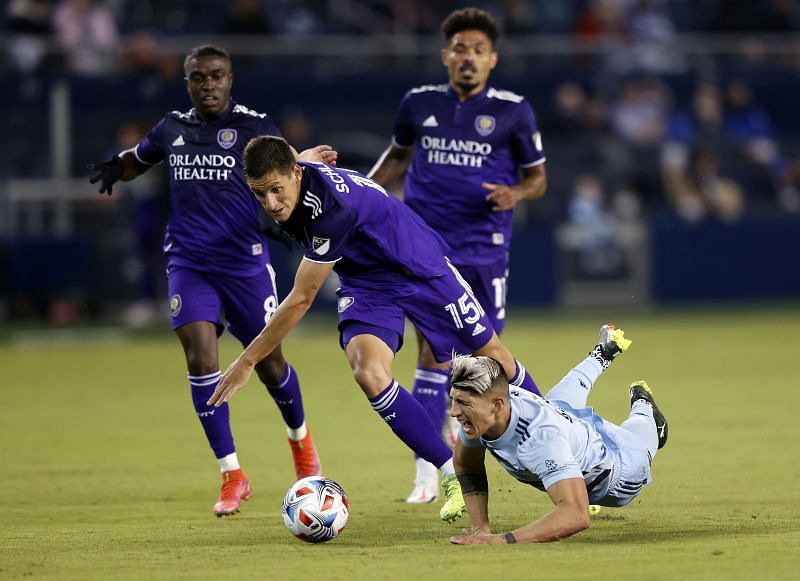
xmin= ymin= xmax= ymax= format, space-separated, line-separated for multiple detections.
xmin=209 ymin=136 xmax=534 ymax=521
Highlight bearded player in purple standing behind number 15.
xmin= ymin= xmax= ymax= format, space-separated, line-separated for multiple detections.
xmin=369 ymin=8 xmax=547 ymax=503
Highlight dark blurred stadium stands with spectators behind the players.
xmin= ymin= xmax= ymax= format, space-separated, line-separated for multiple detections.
xmin=0 ymin=0 xmax=800 ymax=326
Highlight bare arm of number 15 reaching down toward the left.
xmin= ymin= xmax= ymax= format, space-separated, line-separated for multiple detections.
xmin=207 ymin=260 xmax=334 ymax=407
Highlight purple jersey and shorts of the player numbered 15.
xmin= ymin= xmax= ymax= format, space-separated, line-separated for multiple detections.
xmin=281 ymin=163 xmax=493 ymax=361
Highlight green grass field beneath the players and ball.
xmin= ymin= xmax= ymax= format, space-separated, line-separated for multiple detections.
xmin=0 ymin=304 xmax=800 ymax=581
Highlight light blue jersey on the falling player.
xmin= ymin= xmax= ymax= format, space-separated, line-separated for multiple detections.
xmin=460 ymin=388 xmax=621 ymax=504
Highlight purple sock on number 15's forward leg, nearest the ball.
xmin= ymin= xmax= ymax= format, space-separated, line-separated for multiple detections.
xmin=369 ymin=381 xmax=453 ymax=468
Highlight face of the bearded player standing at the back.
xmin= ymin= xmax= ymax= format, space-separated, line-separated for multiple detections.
xmin=442 ymin=30 xmax=497 ymax=97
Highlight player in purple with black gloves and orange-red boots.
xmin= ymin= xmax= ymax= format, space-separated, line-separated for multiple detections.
xmin=89 ymin=45 xmax=336 ymax=516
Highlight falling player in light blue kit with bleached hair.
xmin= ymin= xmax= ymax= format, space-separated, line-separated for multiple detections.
xmin=450 ymin=324 xmax=668 ymax=545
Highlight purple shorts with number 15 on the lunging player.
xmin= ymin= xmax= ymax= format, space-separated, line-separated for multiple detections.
xmin=337 ymin=266 xmax=494 ymax=363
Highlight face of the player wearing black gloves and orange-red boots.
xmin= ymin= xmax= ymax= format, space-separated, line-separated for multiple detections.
xmin=186 ymin=56 xmax=233 ymax=119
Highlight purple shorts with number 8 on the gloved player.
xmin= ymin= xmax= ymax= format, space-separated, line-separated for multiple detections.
xmin=167 ymin=264 xmax=278 ymax=346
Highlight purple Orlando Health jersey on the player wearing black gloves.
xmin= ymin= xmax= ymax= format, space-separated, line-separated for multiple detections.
xmin=134 ymin=101 xmax=280 ymax=276
